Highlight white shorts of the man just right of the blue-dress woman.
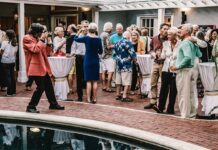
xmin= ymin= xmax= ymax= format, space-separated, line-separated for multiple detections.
xmin=102 ymin=57 xmax=115 ymax=72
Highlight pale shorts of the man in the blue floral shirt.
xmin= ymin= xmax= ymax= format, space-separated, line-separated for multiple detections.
xmin=116 ymin=72 xmax=132 ymax=86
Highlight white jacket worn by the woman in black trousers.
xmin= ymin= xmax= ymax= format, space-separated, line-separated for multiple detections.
xmin=161 ymin=41 xmax=181 ymax=72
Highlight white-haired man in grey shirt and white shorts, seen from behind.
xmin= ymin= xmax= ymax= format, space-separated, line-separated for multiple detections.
xmin=101 ymin=22 xmax=115 ymax=92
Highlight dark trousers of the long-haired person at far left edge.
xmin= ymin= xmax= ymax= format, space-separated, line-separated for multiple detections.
xmin=2 ymin=63 xmax=16 ymax=95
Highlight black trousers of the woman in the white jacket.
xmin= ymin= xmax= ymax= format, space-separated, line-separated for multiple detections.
xmin=158 ymin=72 xmax=177 ymax=113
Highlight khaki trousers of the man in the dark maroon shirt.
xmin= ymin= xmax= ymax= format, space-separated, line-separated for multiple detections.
xmin=150 ymin=63 xmax=163 ymax=104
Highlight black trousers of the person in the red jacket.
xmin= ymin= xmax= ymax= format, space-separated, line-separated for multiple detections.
xmin=28 ymin=74 xmax=58 ymax=108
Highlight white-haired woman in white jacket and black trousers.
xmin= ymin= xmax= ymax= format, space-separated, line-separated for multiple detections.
xmin=154 ymin=27 xmax=180 ymax=114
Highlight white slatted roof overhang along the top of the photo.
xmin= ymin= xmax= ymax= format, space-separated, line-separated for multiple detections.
xmin=1 ymin=0 xmax=218 ymax=11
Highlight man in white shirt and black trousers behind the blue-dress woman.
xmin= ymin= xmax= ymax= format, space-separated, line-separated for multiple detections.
xmin=71 ymin=20 xmax=89 ymax=101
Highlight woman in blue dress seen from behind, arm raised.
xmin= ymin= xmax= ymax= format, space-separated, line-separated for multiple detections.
xmin=75 ymin=23 xmax=102 ymax=104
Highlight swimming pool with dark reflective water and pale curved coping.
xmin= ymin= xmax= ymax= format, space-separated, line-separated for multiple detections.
xmin=0 ymin=110 xmax=209 ymax=150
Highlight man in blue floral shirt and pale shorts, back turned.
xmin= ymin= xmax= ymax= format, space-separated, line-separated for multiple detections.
xmin=113 ymin=31 xmax=136 ymax=102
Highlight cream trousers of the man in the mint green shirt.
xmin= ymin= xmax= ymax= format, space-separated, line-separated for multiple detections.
xmin=176 ymin=68 xmax=197 ymax=118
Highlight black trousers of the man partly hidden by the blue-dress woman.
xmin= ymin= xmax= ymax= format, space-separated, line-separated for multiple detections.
xmin=76 ymin=55 xmax=85 ymax=99
